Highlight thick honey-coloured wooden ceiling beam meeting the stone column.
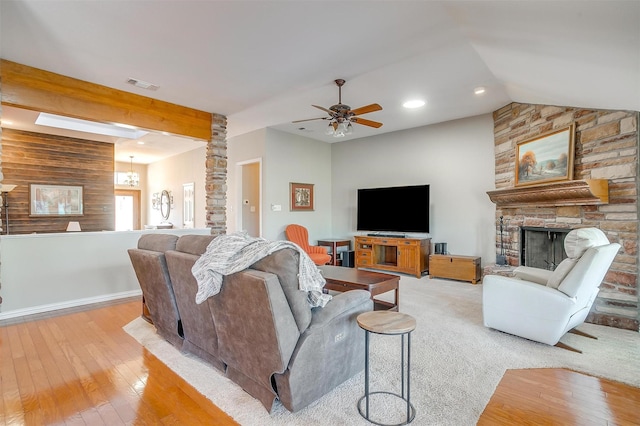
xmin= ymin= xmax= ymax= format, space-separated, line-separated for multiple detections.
xmin=0 ymin=59 xmax=212 ymax=141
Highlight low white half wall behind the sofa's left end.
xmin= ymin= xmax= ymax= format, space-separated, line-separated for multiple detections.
xmin=0 ymin=229 xmax=211 ymax=319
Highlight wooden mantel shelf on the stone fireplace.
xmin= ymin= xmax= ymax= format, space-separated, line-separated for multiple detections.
xmin=487 ymin=179 xmax=609 ymax=208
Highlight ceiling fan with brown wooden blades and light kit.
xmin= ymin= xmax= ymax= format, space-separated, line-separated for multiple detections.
xmin=293 ymin=79 xmax=382 ymax=137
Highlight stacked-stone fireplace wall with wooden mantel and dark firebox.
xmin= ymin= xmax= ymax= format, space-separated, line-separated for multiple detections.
xmin=488 ymin=103 xmax=640 ymax=331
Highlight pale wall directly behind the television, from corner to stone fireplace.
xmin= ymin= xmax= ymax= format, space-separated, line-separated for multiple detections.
xmin=331 ymin=114 xmax=496 ymax=264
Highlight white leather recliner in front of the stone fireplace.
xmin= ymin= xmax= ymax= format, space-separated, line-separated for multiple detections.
xmin=482 ymin=228 xmax=620 ymax=352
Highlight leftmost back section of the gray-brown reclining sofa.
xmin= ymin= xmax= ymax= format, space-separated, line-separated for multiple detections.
xmin=128 ymin=234 xmax=183 ymax=349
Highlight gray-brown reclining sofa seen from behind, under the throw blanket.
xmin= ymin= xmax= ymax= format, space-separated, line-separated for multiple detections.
xmin=129 ymin=234 xmax=373 ymax=411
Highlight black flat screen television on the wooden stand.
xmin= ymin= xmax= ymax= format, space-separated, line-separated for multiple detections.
xmin=357 ymin=185 xmax=429 ymax=233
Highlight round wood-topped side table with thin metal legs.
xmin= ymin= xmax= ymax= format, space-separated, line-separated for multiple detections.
xmin=357 ymin=311 xmax=416 ymax=426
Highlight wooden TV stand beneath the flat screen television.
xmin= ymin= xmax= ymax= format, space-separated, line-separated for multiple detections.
xmin=355 ymin=236 xmax=431 ymax=278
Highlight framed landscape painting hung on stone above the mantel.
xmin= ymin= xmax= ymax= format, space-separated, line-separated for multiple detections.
xmin=515 ymin=124 xmax=575 ymax=186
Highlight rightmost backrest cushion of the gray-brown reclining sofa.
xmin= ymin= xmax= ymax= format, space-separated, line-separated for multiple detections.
xmin=251 ymin=248 xmax=311 ymax=332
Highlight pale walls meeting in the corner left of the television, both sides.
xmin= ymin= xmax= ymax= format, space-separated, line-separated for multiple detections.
xmin=227 ymin=114 xmax=496 ymax=264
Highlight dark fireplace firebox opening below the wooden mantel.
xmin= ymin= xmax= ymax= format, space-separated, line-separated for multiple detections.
xmin=520 ymin=226 xmax=571 ymax=271
